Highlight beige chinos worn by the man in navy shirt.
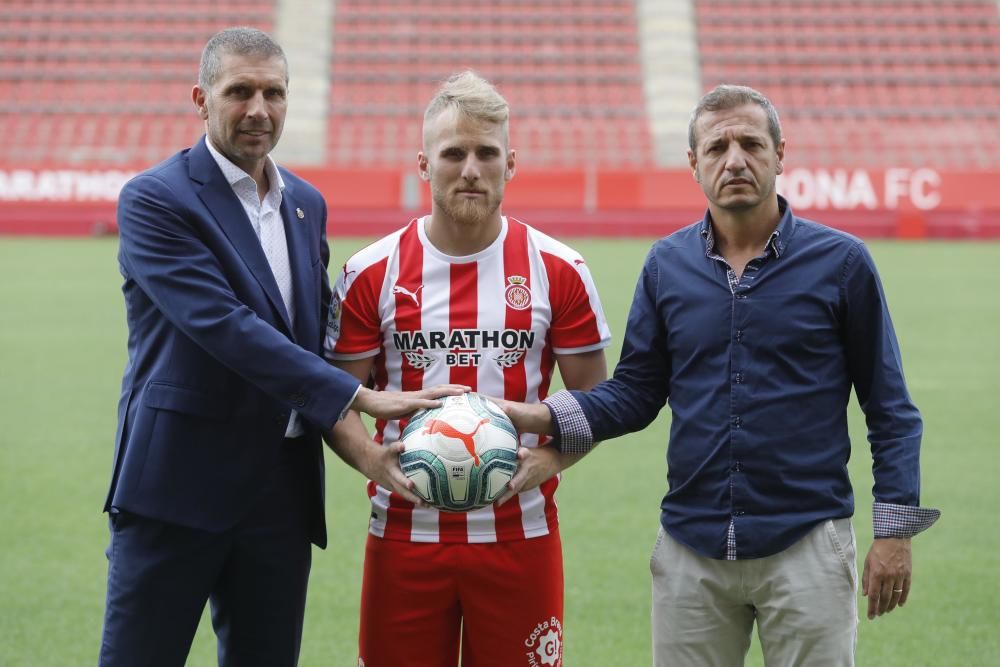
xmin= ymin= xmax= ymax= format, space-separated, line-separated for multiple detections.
xmin=650 ymin=519 xmax=858 ymax=667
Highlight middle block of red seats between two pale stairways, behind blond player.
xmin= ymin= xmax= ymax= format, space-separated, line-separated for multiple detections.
xmin=328 ymin=0 xmax=653 ymax=168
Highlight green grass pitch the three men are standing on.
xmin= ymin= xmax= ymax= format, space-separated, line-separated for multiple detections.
xmin=0 ymin=239 xmax=1000 ymax=667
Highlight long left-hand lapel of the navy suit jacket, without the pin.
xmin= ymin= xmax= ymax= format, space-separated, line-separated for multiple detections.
xmin=188 ymin=137 xmax=298 ymax=333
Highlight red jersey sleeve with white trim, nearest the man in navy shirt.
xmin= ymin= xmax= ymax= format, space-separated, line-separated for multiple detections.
xmin=542 ymin=249 xmax=611 ymax=354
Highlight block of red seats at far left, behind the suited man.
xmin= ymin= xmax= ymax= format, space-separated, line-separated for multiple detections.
xmin=0 ymin=0 xmax=275 ymax=167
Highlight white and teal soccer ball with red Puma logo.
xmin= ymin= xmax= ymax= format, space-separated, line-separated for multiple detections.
xmin=399 ymin=393 xmax=519 ymax=512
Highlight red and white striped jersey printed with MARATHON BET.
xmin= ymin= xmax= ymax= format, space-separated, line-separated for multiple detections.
xmin=326 ymin=217 xmax=611 ymax=542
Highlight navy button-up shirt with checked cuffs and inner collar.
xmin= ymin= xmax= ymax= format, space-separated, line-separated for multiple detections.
xmin=546 ymin=199 xmax=937 ymax=559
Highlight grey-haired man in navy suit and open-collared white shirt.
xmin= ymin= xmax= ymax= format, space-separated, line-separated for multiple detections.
xmin=100 ymin=28 xmax=461 ymax=667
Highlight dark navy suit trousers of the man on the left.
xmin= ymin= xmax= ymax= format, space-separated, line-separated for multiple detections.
xmin=99 ymin=441 xmax=312 ymax=667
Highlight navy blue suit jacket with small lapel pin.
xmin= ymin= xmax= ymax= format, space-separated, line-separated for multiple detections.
xmin=105 ymin=138 xmax=358 ymax=546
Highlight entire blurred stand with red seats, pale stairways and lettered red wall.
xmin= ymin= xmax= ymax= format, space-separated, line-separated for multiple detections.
xmin=0 ymin=0 xmax=1000 ymax=238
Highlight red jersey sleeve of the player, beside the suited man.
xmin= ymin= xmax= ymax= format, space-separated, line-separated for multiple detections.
xmin=324 ymin=258 xmax=388 ymax=361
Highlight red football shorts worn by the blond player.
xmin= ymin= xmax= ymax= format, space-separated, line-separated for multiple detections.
xmin=358 ymin=532 xmax=563 ymax=667
